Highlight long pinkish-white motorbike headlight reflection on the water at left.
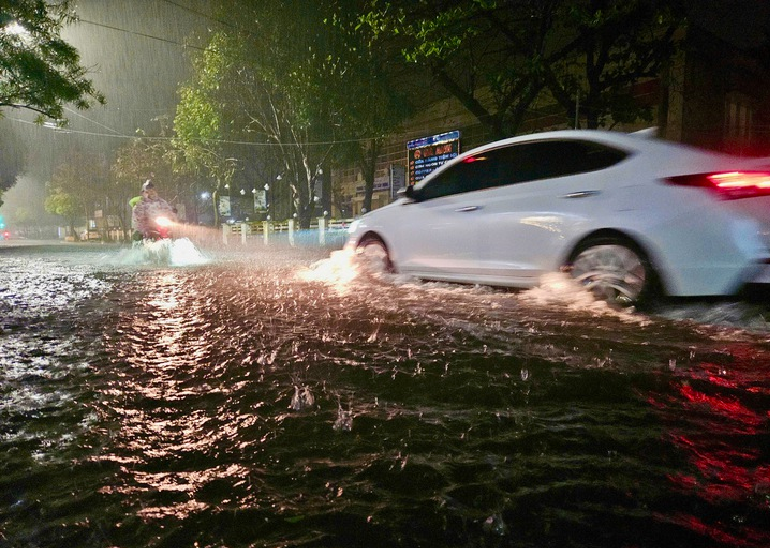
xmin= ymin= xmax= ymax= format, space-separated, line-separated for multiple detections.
xmin=97 ymin=270 xmax=231 ymax=519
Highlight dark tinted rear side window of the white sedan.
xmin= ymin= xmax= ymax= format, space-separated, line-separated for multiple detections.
xmin=492 ymin=140 xmax=627 ymax=186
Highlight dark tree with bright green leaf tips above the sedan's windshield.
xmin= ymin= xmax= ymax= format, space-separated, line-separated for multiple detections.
xmin=361 ymin=0 xmax=563 ymax=139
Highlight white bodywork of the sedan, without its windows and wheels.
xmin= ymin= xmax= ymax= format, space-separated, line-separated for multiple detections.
xmin=348 ymin=131 xmax=770 ymax=296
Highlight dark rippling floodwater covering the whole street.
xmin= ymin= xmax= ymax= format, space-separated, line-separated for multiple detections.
xmin=0 ymin=240 xmax=770 ymax=548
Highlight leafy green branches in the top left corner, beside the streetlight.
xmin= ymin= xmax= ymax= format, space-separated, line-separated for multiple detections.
xmin=0 ymin=0 xmax=104 ymax=121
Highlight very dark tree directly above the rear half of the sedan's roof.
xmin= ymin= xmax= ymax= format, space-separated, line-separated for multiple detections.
xmin=543 ymin=0 xmax=688 ymax=129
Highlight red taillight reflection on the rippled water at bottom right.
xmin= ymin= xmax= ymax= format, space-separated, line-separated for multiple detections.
xmin=648 ymin=344 xmax=770 ymax=548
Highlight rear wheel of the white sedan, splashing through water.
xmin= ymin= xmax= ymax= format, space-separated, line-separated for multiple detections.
xmin=570 ymin=238 xmax=656 ymax=307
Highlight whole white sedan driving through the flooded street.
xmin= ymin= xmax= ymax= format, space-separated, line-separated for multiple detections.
xmin=346 ymin=131 xmax=770 ymax=305
